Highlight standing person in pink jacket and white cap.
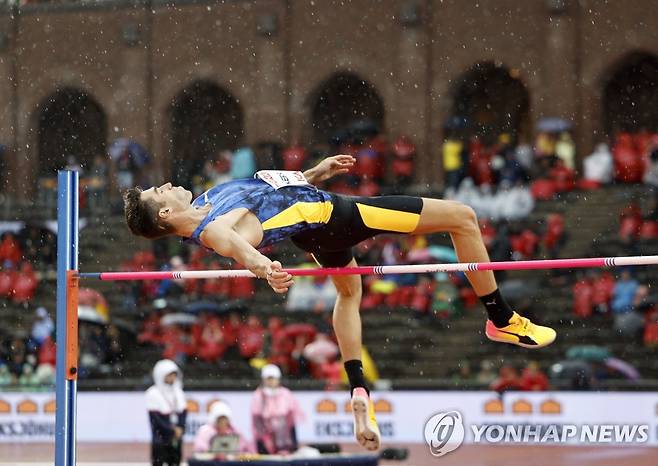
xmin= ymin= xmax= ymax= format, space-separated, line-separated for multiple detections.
xmin=251 ymin=364 xmax=304 ymax=455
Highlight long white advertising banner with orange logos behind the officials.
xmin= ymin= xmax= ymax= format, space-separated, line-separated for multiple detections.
xmin=0 ymin=391 xmax=658 ymax=445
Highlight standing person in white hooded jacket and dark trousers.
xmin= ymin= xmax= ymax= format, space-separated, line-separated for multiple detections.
xmin=146 ymin=359 xmax=187 ymax=466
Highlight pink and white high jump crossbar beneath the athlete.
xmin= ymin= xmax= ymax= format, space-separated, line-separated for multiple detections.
xmin=79 ymin=256 xmax=658 ymax=281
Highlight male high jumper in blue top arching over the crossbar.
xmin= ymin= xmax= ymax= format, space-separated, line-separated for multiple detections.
xmin=124 ymin=155 xmax=555 ymax=450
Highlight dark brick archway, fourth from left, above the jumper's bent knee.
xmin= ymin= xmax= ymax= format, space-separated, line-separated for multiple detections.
xmin=451 ymin=61 xmax=530 ymax=143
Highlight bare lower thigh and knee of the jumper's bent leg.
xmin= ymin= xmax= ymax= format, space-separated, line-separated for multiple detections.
xmin=412 ymin=198 xmax=475 ymax=234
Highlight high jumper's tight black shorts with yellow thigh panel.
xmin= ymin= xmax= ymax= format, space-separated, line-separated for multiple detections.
xmin=291 ymin=194 xmax=423 ymax=267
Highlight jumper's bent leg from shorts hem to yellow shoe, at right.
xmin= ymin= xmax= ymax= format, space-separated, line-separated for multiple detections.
xmin=413 ymin=198 xmax=556 ymax=348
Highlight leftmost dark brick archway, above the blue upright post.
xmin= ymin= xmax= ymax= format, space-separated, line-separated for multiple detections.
xmin=36 ymin=87 xmax=107 ymax=176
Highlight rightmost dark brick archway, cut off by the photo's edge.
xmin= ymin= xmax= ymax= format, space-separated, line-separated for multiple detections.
xmin=601 ymin=51 xmax=658 ymax=135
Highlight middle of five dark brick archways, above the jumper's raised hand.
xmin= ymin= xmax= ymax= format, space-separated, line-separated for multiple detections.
xmin=309 ymin=72 xmax=385 ymax=142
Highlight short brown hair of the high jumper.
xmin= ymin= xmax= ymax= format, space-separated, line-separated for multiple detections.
xmin=123 ymin=188 xmax=174 ymax=239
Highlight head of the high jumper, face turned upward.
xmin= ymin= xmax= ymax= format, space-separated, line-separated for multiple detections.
xmin=123 ymin=183 xmax=192 ymax=239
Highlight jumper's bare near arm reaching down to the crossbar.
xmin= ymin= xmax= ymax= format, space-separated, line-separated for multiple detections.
xmin=202 ymin=223 xmax=293 ymax=293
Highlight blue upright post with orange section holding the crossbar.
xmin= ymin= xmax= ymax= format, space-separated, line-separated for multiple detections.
xmin=55 ymin=170 xmax=78 ymax=466
